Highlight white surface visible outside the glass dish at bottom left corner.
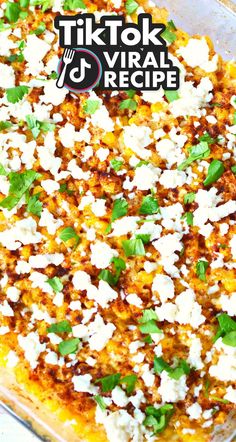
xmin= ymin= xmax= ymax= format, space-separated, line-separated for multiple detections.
xmin=0 ymin=407 xmax=39 ymax=442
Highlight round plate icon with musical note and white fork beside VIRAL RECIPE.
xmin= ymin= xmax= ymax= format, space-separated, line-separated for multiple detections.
xmin=57 ymin=49 xmax=102 ymax=92
